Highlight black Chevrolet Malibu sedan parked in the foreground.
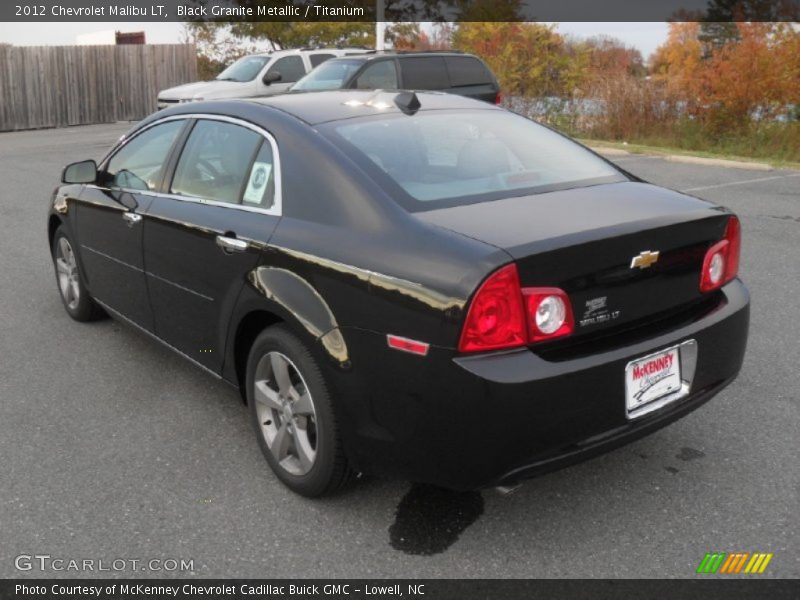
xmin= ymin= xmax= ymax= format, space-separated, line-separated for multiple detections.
xmin=48 ymin=90 xmax=749 ymax=496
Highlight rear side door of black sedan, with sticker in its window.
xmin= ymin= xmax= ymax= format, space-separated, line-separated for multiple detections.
xmin=144 ymin=116 xmax=281 ymax=372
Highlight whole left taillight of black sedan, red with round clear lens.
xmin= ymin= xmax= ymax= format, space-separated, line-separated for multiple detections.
xmin=458 ymin=264 xmax=574 ymax=352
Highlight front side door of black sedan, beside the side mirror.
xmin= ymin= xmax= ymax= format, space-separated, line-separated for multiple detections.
xmin=77 ymin=121 xmax=186 ymax=331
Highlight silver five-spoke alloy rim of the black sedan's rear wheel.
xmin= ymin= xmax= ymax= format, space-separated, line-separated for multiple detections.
xmin=253 ymin=351 xmax=317 ymax=476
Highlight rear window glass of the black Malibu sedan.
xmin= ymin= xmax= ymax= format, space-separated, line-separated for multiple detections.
xmin=326 ymin=109 xmax=627 ymax=210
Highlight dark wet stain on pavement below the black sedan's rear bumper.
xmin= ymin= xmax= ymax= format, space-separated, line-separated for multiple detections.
xmin=389 ymin=484 xmax=483 ymax=556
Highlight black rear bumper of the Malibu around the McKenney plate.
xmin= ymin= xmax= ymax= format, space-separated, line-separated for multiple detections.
xmin=339 ymin=280 xmax=749 ymax=489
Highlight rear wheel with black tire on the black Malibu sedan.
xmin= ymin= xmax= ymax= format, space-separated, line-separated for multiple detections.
xmin=246 ymin=325 xmax=351 ymax=497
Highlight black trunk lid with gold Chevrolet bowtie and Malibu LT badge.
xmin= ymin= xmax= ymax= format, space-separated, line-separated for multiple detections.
xmin=416 ymin=182 xmax=728 ymax=340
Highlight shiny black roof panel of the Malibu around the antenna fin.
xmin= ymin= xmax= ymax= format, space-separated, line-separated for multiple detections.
xmin=242 ymin=89 xmax=501 ymax=125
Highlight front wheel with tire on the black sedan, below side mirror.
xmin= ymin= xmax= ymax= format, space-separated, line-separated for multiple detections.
xmin=52 ymin=225 xmax=106 ymax=322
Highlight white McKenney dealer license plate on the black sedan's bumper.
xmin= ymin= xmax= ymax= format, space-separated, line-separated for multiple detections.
xmin=625 ymin=346 xmax=681 ymax=416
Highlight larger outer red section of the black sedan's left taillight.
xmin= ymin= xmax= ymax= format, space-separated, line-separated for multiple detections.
xmin=458 ymin=264 xmax=527 ymax=352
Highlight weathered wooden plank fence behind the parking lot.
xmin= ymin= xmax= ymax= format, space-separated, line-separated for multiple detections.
xmin=0 ymin=44 xmax=197 ymax=131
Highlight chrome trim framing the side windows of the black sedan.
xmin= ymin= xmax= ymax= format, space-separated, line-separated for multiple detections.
xmin=92 ymin=113 xmax=283 ymax=217
